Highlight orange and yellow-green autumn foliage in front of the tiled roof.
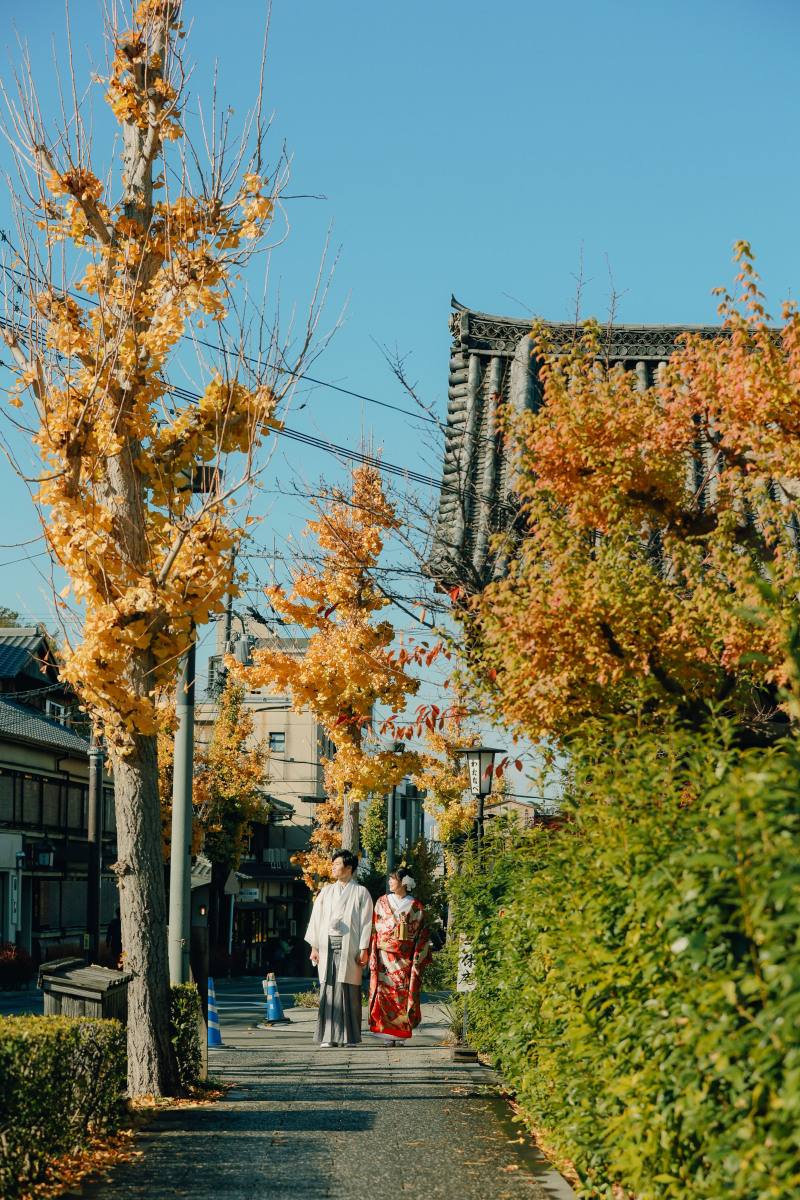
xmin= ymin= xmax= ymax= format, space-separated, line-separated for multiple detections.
xmin=463 ymin=244 xmax=800 ymax=740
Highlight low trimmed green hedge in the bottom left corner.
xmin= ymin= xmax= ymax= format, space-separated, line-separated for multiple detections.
xmin=0 ymin=1016 xmax=126 ymax=1200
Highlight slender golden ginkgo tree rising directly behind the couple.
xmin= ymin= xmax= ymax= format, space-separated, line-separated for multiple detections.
xmin=228 ymin=464 xmax=431 ymax=889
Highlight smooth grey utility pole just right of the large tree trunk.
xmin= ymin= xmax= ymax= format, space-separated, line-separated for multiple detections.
xmin=169 ymin=625 xmax=196 ymax=983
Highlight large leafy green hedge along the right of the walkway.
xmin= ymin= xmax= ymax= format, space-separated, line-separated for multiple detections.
xmin=455 ymin=727 xmax=800 ymax=1200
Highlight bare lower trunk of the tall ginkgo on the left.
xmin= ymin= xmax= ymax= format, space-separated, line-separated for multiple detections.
xmin=114 ymin=736 xmax=181 ymax=1096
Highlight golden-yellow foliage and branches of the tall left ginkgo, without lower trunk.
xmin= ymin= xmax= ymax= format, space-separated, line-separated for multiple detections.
xmin=4 ymin=0 xmax=284 ymax=755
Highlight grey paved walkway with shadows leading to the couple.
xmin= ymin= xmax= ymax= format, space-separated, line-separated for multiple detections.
xmin=83 ymin=980 xmax=573 ymax=1200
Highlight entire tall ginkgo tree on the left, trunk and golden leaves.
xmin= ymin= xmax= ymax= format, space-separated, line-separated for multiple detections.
xmin=4 ymin=0 xmax=319 ymax=1094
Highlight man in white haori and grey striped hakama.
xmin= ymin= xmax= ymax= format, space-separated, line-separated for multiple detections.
xmin=306 ymin=850 xmax=373 ymax=1046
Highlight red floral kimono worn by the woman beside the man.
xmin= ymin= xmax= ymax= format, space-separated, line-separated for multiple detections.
xmin=369 ymin=895 xmax=431 ymax=1038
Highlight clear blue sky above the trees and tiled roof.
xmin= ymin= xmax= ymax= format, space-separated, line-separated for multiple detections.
xmin=0 ymin=0 xmax=800 ymax=768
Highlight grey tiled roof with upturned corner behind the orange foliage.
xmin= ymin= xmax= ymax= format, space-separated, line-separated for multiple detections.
xmin=429 ymin=298 xmax=734 ymax=594
